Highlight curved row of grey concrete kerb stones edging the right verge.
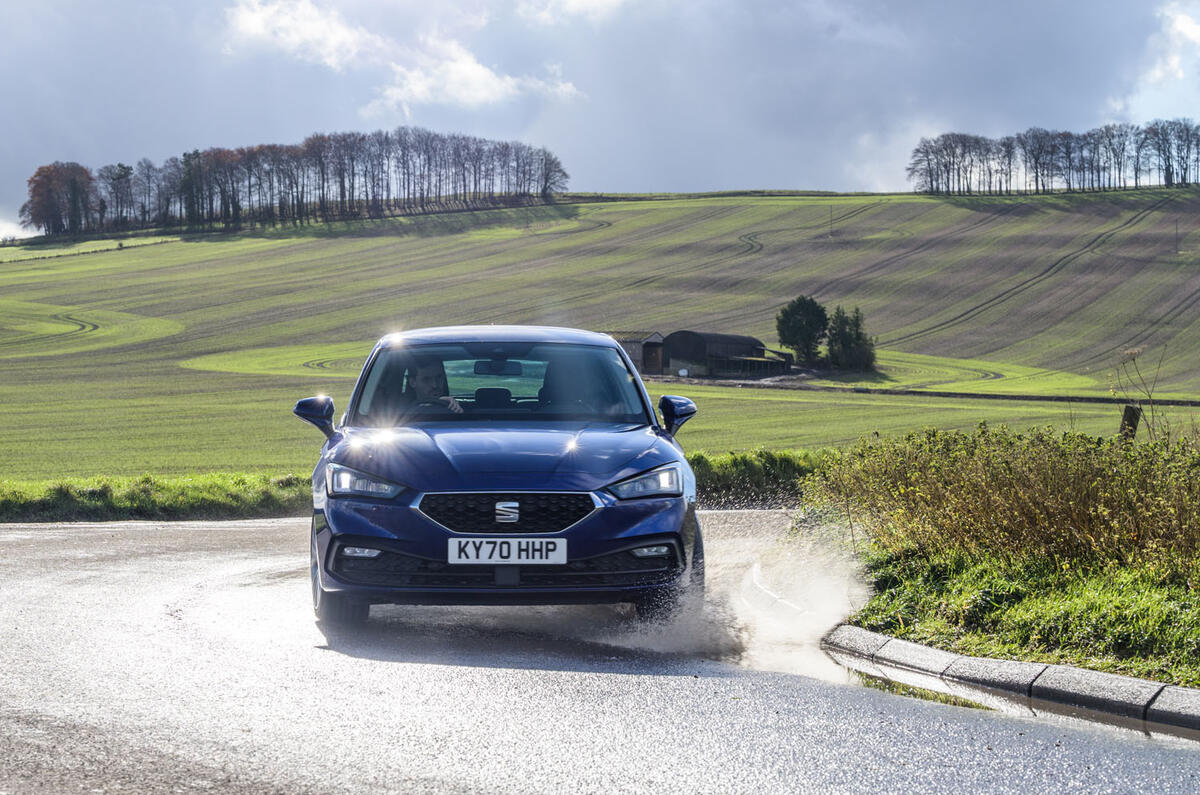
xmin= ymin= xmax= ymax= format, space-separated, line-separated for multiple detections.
xmin=821 ymin=624 xmax=1200 ymax=729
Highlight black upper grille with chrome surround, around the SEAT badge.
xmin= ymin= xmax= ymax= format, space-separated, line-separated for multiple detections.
xmin=420 ymin=491 xmax=595 ymax=533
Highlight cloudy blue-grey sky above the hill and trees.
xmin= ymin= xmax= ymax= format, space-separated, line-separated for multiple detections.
xmin=0 ymin=0 xmax=1200 ymax=234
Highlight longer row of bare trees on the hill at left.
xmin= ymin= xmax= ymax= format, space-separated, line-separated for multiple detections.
xmin=20 ymin=127 xmax=569 ymax=235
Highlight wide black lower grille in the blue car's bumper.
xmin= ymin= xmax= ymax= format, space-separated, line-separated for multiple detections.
xmin=334 ymin=551 xmax=679 ymax=588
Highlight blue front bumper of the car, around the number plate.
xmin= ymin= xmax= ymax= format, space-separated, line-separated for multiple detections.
xmin=312 ymin=494 xmax=697 ymax=604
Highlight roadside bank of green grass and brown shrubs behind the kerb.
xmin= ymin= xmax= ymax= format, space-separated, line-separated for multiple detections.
xmin=806 ymin=426 xmax=1200 ymax=686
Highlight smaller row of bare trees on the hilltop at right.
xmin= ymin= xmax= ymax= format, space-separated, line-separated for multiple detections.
xmin=907 ymin=119 xmax=1200 ymax=195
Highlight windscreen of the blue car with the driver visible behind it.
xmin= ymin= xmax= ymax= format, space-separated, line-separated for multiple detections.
xmin=350 ymin=342 xmax=649 ymax=426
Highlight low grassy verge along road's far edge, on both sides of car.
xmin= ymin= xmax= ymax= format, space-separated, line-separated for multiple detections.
xmin=0 ymin=450 xmax=827 ymax=522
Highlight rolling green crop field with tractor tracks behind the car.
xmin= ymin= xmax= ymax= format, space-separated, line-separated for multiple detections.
xmin=0 ymin=191 xmax=1200 ymax=479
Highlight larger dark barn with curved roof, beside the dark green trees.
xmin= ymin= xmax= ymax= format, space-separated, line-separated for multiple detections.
xmin=662 ymin=330 xmax=792 ymax=376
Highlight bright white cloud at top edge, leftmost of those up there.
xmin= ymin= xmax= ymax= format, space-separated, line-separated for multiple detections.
xmin=226 ymin=0 xmax=388 ymax=71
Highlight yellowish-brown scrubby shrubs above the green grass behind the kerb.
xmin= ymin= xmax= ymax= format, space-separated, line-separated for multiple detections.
xmin=806 ymin=424 xmax=1200 ymax=576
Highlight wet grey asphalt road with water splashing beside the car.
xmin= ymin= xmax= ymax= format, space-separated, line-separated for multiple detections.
xmin=0 ymin=512 xmax=1200 ymax=793
